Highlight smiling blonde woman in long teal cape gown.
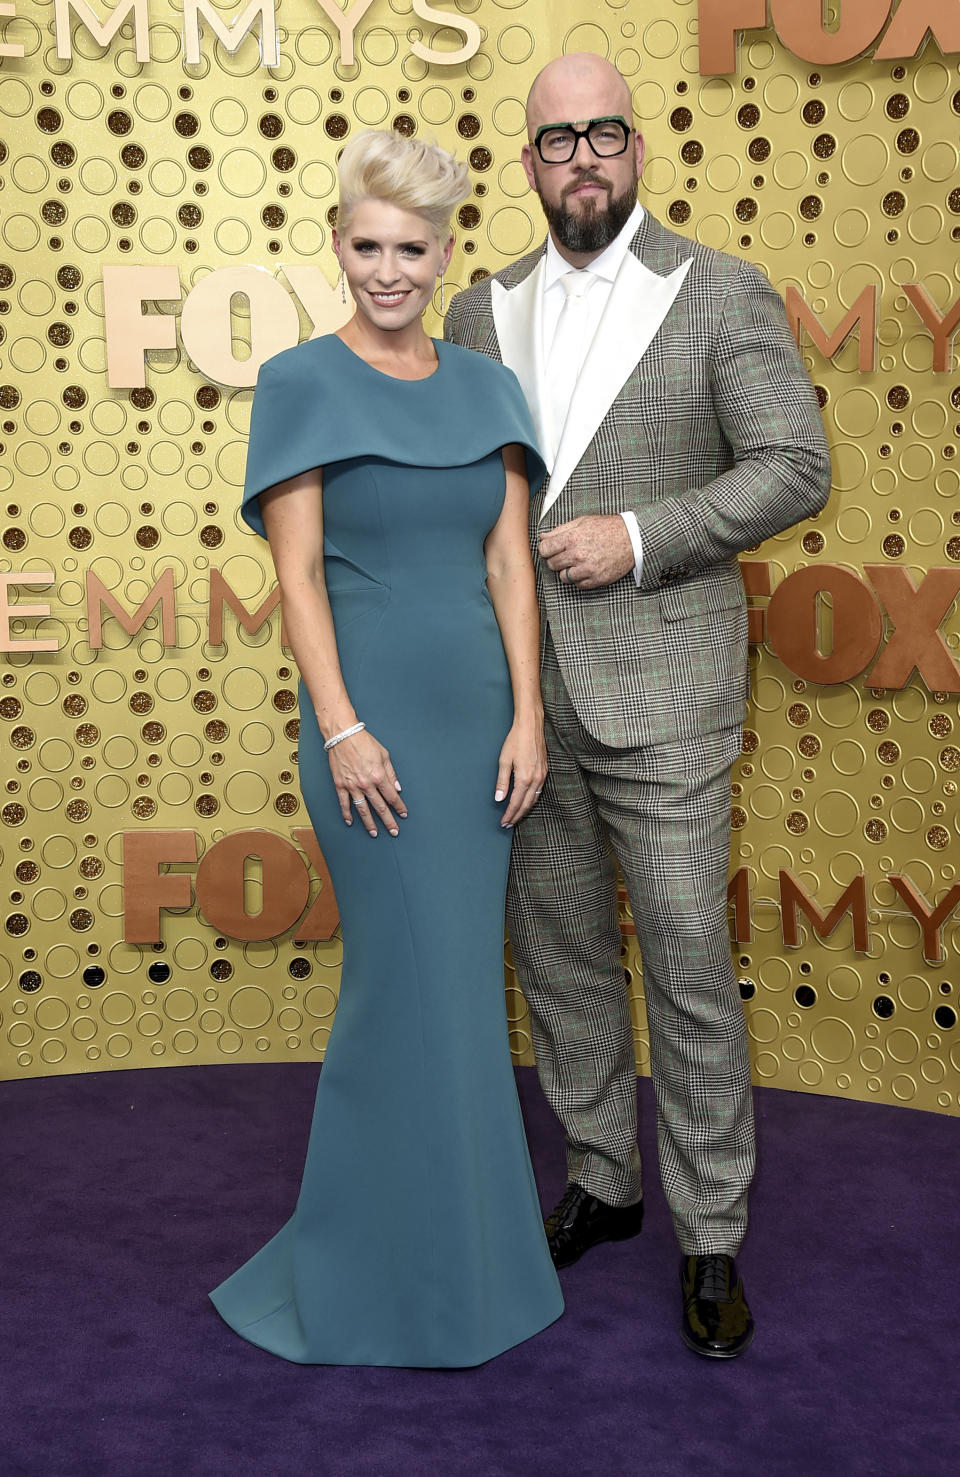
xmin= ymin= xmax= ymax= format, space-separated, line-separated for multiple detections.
xmin=211 ymin=131 xmax=563 ymax=1368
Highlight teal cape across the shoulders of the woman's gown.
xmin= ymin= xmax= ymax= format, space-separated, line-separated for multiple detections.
xmin=241 ymin=335 xmax=546 ymax=538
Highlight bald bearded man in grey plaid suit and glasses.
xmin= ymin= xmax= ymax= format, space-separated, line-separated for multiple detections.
xmin=446 ymin=53 xmax=830 ymax=1357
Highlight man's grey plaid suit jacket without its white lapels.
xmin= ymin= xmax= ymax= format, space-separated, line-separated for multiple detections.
xmin=445 ymin=211 xmax=830 ymax=747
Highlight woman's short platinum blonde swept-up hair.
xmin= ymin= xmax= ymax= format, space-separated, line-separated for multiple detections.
xmin=337 ymin=128 xmax=470 ymax=239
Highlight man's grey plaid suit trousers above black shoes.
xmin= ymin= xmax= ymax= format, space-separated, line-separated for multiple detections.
xmin=507 ymin=631 xmax=755 ymax=1255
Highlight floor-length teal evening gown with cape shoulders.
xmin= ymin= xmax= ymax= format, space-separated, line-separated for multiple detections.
xmin=211 ymin=335 xmax=563 ymax=1368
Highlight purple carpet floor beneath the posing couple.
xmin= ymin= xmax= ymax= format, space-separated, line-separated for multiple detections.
xmin=0 ymin=1065 xmax=960 ymax=1477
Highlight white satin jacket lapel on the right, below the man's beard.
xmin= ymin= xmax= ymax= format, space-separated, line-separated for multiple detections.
xmin=537 ymin=251 xmax=693 ymax=518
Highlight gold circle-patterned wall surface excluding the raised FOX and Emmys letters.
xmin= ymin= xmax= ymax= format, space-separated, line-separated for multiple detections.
xmin=0 ymin=0 xmax=960 ymax=1112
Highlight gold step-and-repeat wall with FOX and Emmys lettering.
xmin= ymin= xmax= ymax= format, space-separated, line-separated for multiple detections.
xmin=0 ymin=0 xmax=960 ymax=1112
